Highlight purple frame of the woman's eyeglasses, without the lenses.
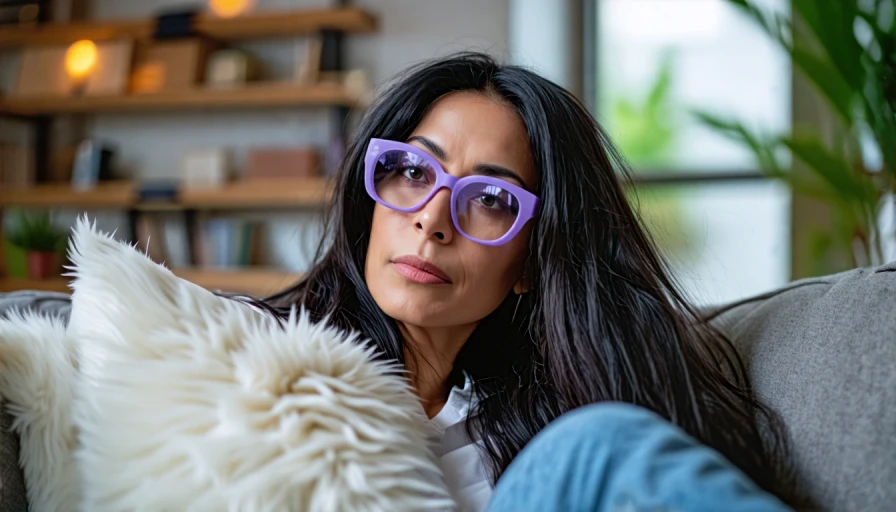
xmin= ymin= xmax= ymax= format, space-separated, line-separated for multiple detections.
xmin=364 ymin=138 xmax=539 ymax=246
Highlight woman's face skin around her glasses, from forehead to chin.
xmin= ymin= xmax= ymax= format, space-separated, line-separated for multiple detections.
xmin=365 ymin=92 xmax=537 ymax=327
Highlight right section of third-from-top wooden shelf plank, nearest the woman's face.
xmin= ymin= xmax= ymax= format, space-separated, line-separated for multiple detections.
xmin=177 ymin=178 xmax=332 ymax=210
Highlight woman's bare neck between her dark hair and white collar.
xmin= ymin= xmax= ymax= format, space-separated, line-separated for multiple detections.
xmin=399 ymin=323 xmax=476 ymax=418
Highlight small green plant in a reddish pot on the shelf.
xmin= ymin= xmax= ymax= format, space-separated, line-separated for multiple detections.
xmin=7 ymin=212 xmax=67 ymax=279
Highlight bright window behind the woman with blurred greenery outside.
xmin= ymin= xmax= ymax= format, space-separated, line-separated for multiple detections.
xmin=585 ymin=0 xmax=791 ymax=304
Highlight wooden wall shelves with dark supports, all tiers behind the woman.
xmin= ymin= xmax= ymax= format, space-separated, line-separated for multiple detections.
xmin=0 ymin=7 xmax=378 ymax=296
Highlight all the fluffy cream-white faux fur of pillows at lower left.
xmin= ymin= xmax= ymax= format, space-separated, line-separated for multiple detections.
xmin=0 ymin=219 xmax=452 ymax=512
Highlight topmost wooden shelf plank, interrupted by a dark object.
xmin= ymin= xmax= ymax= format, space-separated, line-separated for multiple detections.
xmin=0 ymin=7 xmax=377 ymax=48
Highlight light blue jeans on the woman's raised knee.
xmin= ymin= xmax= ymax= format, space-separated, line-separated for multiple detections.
xmin=488 ymin=403 xmax=790 ymax=512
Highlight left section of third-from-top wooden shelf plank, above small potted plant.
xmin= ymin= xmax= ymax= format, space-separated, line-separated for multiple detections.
xmin=0 ymin=181 xmax=137 ymax=208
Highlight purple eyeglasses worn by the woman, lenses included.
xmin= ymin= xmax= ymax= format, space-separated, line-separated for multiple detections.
xmin=364 ymin=139 xmax=538 ymax=245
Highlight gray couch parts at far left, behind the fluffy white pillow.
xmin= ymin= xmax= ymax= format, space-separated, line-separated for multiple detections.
xmin=0 ymin=291 xmax=71 ymax=511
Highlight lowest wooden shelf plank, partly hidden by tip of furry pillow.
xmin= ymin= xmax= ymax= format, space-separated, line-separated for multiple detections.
xmin=0 ymin=268 xmax=302 ymax=297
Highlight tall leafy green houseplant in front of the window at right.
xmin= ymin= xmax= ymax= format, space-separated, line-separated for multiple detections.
xmin=696 ymin=0 xmax=896 ymax=265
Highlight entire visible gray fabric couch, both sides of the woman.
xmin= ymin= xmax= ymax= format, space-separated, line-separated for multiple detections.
xmin=0 ymin=262 xmax=896 ymax=512
